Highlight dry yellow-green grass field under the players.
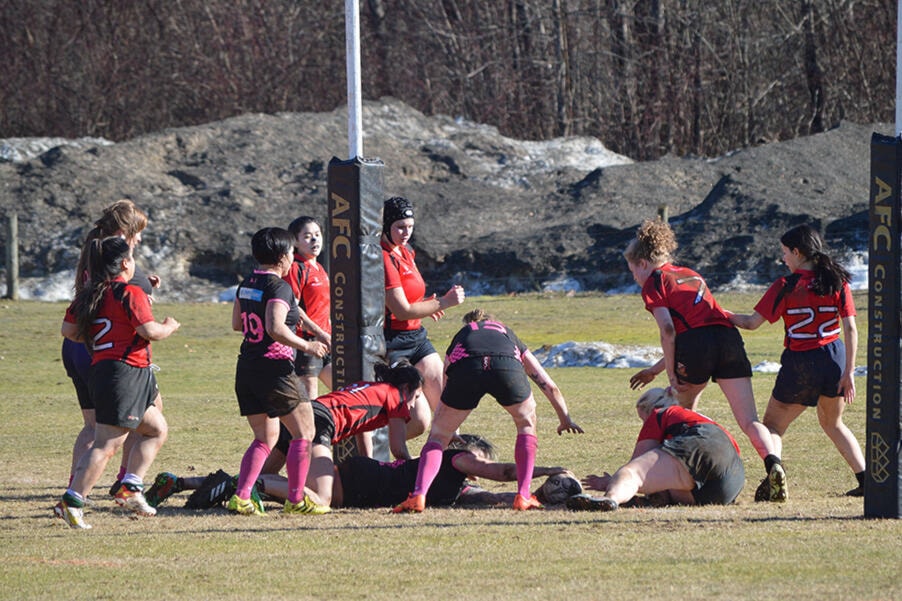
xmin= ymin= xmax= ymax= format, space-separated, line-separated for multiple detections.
xmin=0 ymin=294 xmax=902 ymax=600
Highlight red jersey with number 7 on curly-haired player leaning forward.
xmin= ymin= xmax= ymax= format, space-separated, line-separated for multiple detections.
xmin=642 ymin=263 xmax=733 ymax=334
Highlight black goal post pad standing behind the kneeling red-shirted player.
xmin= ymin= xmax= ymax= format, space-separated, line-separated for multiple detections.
xmin=327 ymin=157 xmax=385 ymax=463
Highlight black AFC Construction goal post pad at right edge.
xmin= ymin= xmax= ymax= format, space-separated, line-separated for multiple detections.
xmin=864 ymin=133 xmax=902 ymax=518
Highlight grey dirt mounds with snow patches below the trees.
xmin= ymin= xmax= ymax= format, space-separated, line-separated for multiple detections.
xmin=0 ymin=98 xmax=893 ymax=300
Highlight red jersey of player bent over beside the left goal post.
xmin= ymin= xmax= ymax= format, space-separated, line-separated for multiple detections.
xmin=313 ymin=382 xmax=410 ymax=444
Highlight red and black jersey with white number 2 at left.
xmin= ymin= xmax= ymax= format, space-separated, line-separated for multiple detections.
xmin=64 ymin=278 xmax=153 ymax=367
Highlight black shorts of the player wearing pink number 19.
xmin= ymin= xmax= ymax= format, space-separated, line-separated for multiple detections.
xmin=235 ymin=357 xmax=309 ymax=417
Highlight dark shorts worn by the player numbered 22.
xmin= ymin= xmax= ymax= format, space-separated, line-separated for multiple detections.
xmin=771 ymin=340 xmax=846 ymax=407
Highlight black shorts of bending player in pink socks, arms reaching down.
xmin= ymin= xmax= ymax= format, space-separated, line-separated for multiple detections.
xmin=442 ymin=357 xmax=532 ymax=411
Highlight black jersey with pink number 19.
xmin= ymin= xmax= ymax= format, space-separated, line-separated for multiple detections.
xmin=236 ymin=271 xmax=300 ymax=360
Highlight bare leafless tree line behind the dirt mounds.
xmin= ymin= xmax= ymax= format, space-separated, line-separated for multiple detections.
xmin=0 ymin=0 xmax=896 ymax=160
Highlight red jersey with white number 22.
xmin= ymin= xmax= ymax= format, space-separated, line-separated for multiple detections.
xmin=755 ymin=269 xmax=855 ymax=351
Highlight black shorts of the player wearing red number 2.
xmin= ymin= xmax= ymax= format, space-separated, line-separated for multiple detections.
xmin=90 ymin=359 xmax=160 ymax=430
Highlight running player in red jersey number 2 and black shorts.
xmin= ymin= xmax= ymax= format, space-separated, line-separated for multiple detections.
xmin=54 ymin=236 xmax=180 ymax=529
